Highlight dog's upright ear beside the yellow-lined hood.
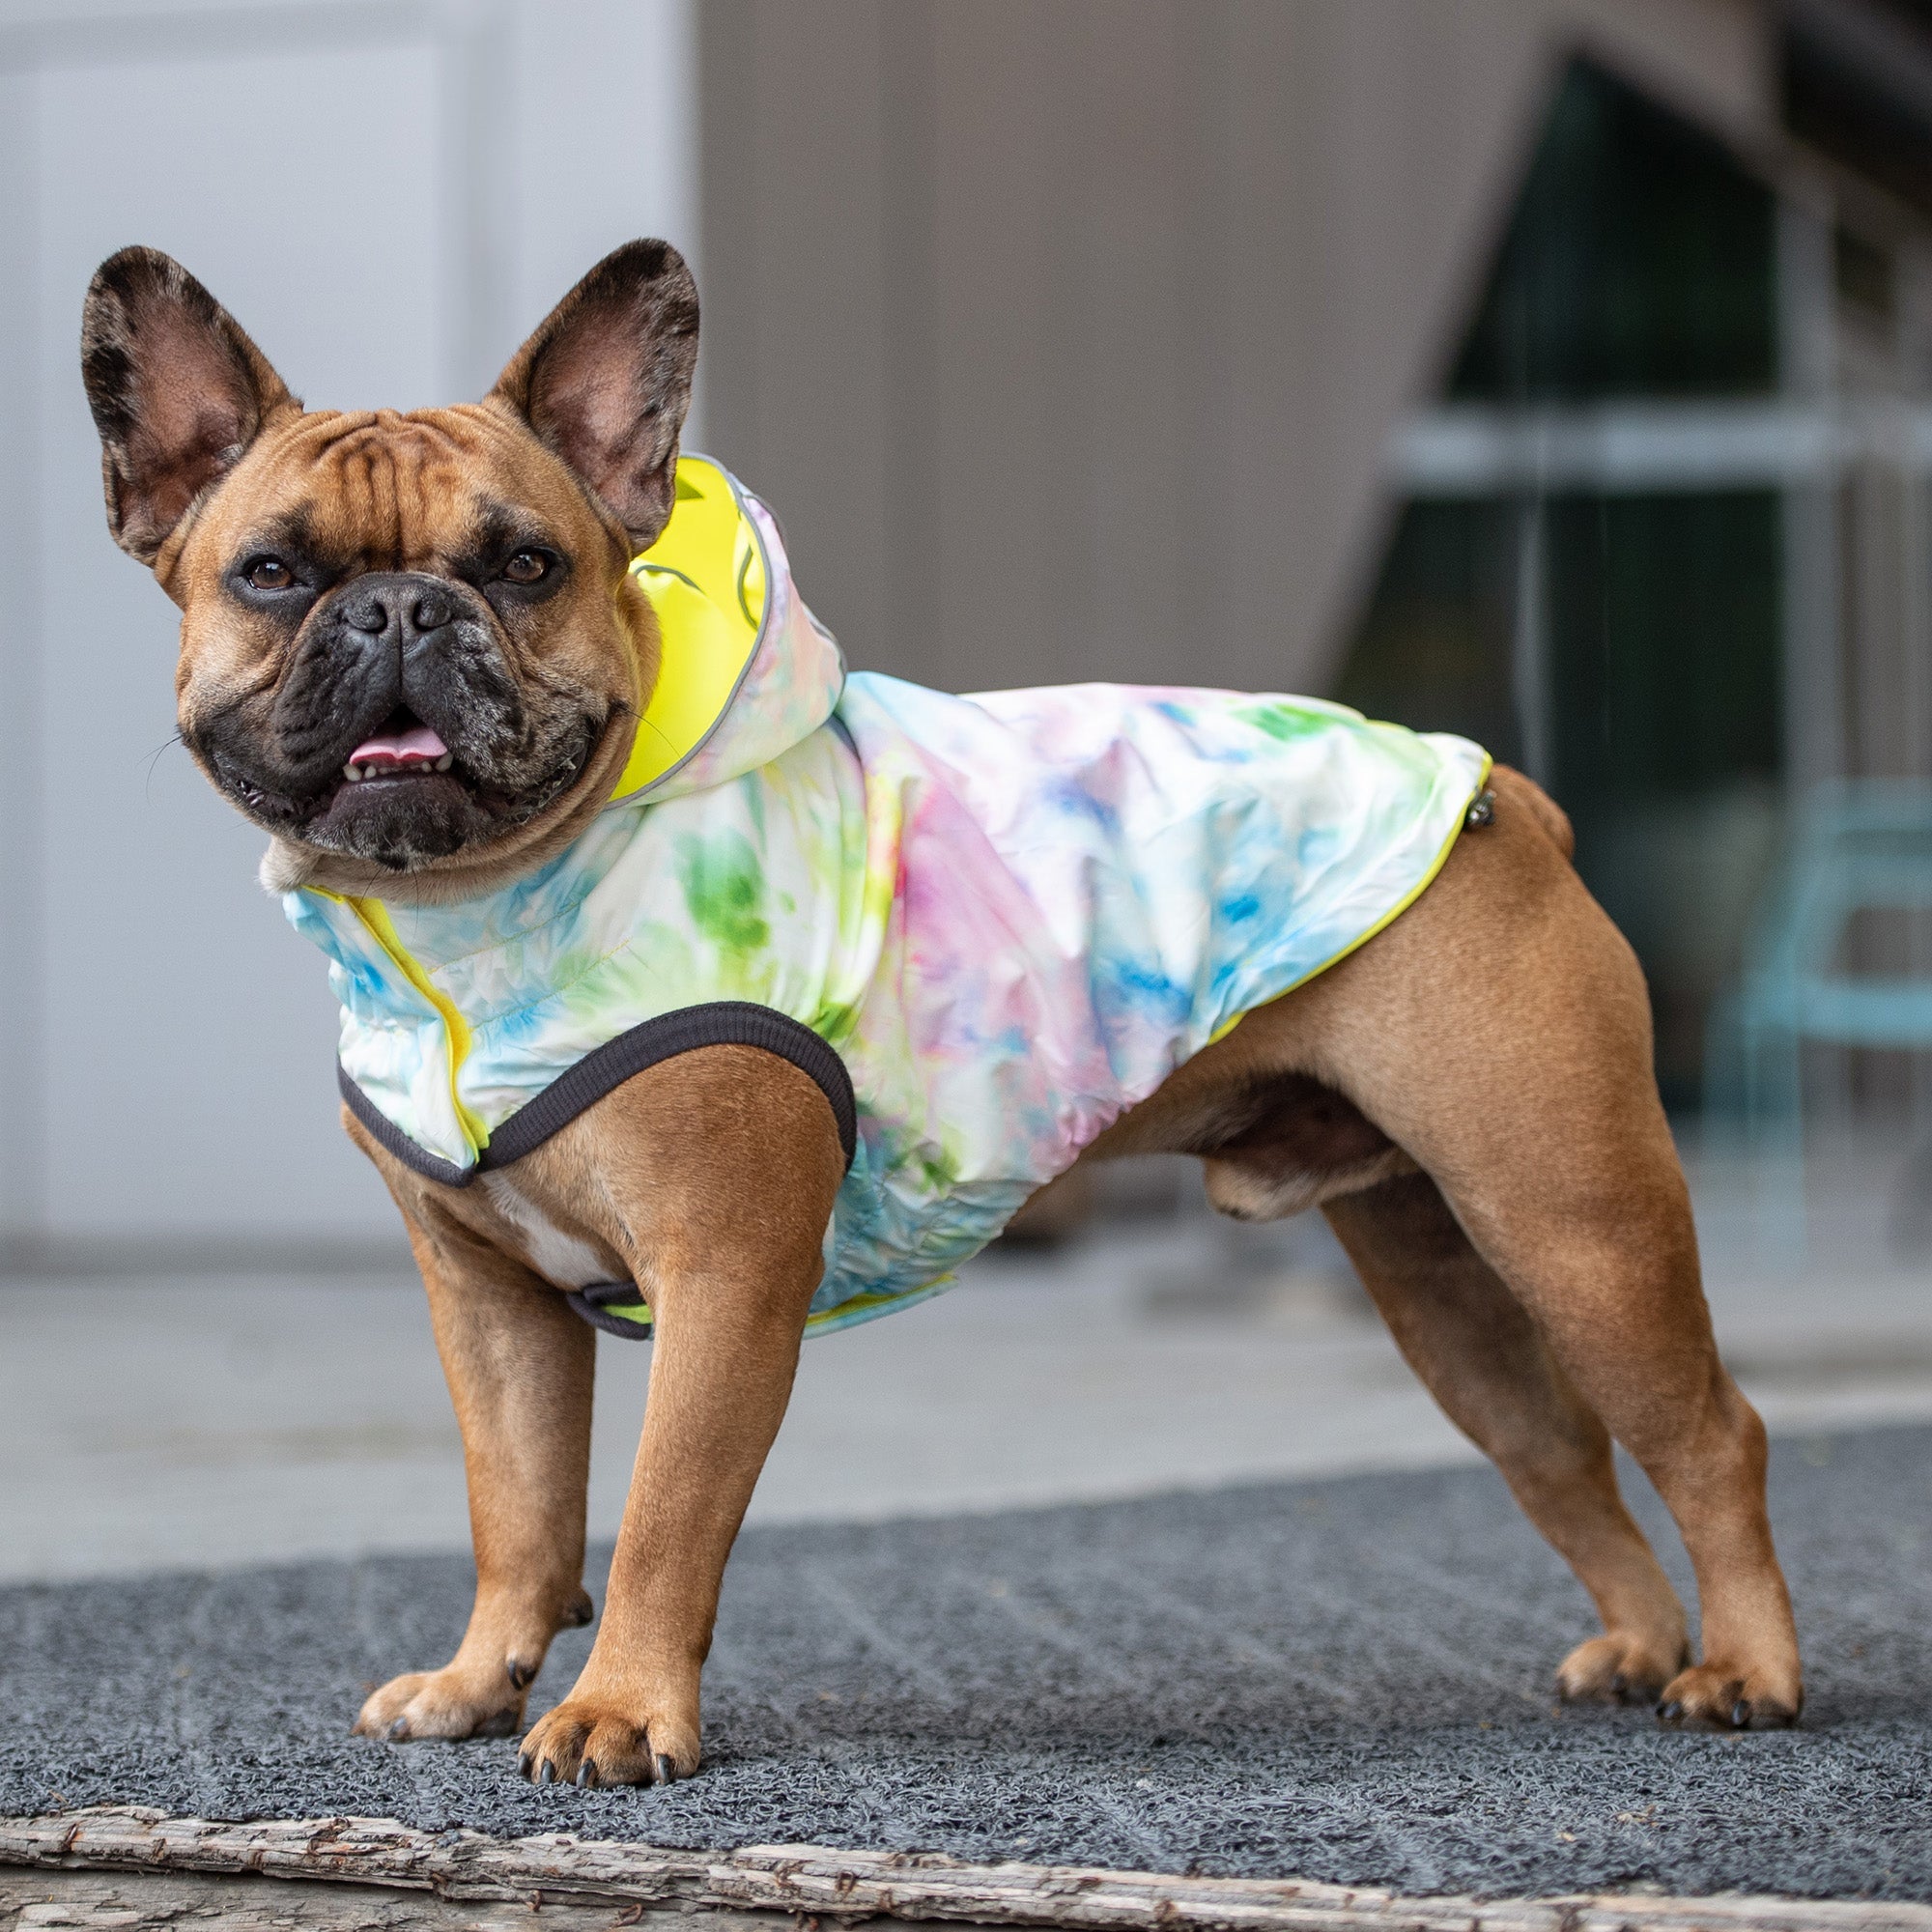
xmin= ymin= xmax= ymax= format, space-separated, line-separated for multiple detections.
xmin=493 ymin=242 xmax=697 ymax=551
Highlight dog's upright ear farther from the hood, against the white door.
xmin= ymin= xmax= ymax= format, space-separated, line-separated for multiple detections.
xmin=81 ymin=247 xmax=301 ymax=564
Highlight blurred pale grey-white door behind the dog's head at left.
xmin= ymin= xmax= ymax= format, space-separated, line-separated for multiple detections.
xmin=0 ymin=0 xmax=697 ymax=1262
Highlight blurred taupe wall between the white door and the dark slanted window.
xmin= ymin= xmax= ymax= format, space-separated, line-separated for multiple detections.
xmin=699 ymin=0 xmax=1774 ymax=690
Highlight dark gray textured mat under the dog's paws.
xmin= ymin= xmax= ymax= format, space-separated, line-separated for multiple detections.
xmin=0 ymin=1428 xmax=1932 ymax=1899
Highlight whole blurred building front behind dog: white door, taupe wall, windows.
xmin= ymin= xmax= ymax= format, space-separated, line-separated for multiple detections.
xmin=0 ymin=0 xmax=1932 ymax=1262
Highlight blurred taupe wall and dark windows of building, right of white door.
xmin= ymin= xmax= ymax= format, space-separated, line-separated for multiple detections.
xmin=701 ymin=0 xmax=1932 ymax=1109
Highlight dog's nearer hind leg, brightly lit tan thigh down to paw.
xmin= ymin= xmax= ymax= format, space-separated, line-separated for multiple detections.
xmin=1283 ymin=773 xmax=1803 ymax=1727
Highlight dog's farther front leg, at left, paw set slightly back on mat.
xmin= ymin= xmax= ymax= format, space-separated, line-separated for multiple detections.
xmin=355 ymin=1221 xmax=597 ymax=1739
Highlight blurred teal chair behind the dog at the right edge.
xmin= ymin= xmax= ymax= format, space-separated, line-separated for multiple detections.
xmin=1704 ymin=779 xmax=1932 ymax=1260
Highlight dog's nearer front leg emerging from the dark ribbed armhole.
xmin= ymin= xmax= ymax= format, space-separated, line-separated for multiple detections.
xmin=520 ymin=1047 xmax=844 ymax=1785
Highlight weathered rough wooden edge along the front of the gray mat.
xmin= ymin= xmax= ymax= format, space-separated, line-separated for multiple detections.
xmin=0 ymin=1806 xmax=1932 ymax=1932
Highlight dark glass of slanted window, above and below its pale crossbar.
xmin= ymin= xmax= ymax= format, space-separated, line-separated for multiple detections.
xmin=1339 ymin=62 xmax=1783 ymax=1109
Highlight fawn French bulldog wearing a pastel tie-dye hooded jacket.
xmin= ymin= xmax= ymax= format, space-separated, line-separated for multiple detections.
xmin=83 ymin=242 xmax=1801 ymax=1785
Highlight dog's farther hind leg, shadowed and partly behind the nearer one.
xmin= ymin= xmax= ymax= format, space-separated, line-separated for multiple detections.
xmin=1323 ymin=1175 xmax=1689 ymax=1700
